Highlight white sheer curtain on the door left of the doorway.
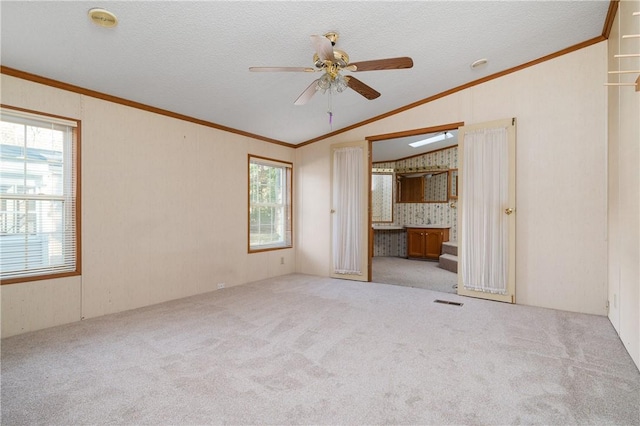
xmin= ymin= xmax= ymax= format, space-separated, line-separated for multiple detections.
xmin=332 ymin=147 xmax=364 ymax=275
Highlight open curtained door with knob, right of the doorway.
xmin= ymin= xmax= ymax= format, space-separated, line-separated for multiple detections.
xmin=458 ymin=118 xmax=516 ymax=303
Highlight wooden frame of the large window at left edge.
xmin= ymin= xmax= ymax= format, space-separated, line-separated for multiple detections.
xmin=0 ymin=103 xmax=82 ymax=285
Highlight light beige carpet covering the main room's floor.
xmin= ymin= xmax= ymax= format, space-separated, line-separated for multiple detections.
xmin=1 ymin=275 xmax=640 ymax=425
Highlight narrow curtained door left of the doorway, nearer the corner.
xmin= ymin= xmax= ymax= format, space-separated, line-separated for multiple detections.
xmin=330 ymin=141 xmax=371 ymax=281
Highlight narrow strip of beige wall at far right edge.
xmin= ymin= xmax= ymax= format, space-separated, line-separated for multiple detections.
xmin=608 ymin=1 xmax=640 ymax=367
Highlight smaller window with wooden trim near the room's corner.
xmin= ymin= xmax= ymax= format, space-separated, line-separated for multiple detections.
xmin=249 ymin=155 xmax=292 ymax=252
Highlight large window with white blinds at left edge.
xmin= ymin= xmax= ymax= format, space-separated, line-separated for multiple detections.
xmin=0 ymin=107 xmax=80 ymax=284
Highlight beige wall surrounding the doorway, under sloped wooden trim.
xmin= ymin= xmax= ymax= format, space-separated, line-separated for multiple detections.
xmin=296 ymin=42 xmax=607 ymax=315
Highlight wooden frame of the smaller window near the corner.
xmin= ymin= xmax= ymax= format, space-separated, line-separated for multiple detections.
xmin=247 ymin=154 xmax=293 ymax=253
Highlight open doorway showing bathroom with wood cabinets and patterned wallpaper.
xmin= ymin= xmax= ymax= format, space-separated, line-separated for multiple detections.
xmin=367 ymin=123 xmax=464 ymax=293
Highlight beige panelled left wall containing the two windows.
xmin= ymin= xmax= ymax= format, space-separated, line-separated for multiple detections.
xmin=0 ymin=75 xmax=298 ymax=337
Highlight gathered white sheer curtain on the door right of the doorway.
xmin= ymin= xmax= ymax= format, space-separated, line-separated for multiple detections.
xmin=460 ymin=128 xmax=509 ymax=294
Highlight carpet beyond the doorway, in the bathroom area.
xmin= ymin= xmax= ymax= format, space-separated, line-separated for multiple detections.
xmin=371 ymin=256 xmax=458 ymax=293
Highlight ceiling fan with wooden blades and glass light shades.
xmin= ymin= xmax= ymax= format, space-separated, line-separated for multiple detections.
xmin=249 ymin=32 xmax=413 ymax=106
